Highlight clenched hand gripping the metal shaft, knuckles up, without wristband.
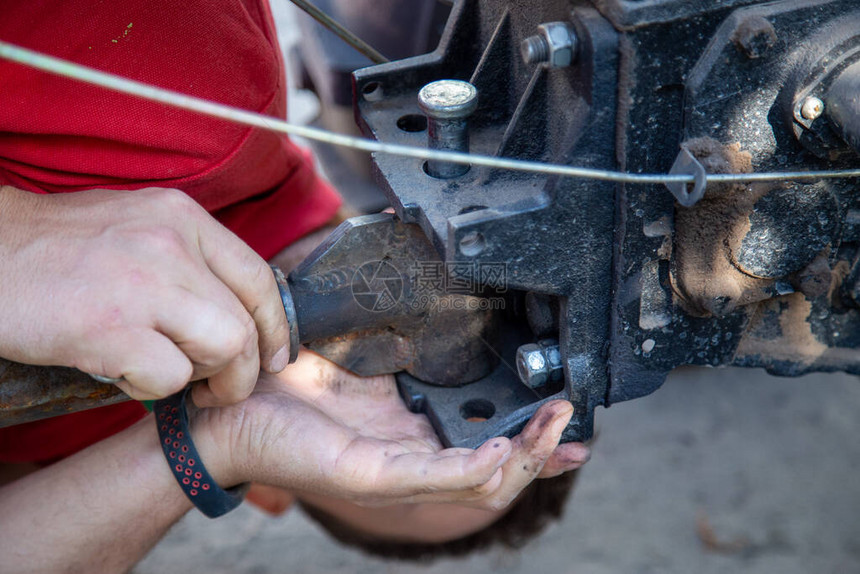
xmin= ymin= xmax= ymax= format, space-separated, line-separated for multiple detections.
xmin=0 ymin=187 xmax=289 ymax=405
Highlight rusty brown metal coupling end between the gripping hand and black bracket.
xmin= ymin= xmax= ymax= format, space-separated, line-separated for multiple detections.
xmin=289 ymin=213 xmax=499 ymax=386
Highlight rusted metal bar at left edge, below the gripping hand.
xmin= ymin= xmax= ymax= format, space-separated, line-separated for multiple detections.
xmin=0 ymin=359 xmax=130 ymax=427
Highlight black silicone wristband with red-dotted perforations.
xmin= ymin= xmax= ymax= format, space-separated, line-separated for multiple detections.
xmin=153 ymin=387 xmax=248 ymax=518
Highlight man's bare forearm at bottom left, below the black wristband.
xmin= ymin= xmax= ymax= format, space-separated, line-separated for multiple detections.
xmin=0 ymin=415 xmax=191 ymax=573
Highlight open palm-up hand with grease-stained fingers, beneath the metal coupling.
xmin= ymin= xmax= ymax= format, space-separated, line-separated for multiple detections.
xmin=193 ymin=352 xmax=588 ymax=510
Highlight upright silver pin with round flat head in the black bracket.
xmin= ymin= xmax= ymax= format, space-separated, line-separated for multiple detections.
xmin=418 ymin=80 xmax=478 ymax=179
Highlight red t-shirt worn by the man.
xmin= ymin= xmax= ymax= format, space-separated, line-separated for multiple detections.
xmin=0 ymin=0 xmax=340 ymax=461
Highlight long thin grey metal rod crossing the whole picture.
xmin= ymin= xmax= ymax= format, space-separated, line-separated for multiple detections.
xmin=0 ymin=41 xmax=860 ymax=189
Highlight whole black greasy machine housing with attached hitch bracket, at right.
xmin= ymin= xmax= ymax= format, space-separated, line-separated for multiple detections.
xmin=355 ymin=0 xmax=860 ymax=446
